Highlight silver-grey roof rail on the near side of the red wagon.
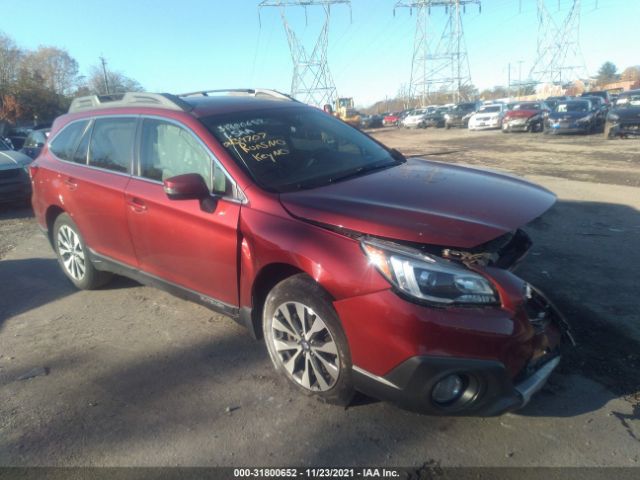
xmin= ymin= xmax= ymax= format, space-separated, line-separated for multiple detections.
xmin=69 ymin=92 xmax=193 ymax=113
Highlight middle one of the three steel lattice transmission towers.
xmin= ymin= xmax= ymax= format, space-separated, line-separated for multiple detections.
xmin=393 ymin=0 xmax=482 ymax=105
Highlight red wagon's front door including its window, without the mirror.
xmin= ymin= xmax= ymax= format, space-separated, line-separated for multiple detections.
xmin=125 ymin=118 xmax=241 ymax=307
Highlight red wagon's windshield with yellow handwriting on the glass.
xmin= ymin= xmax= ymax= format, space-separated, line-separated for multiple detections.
xmin=202 ymin=108 xmax=401 ymax=192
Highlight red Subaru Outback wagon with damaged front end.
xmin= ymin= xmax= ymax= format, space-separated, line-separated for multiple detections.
xmin=30 ymin=90 xmax=565 ymax=415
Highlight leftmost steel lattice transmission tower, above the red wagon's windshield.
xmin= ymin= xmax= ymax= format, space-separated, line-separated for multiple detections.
xmin=258 ymin=0 xmax=351 ymax=107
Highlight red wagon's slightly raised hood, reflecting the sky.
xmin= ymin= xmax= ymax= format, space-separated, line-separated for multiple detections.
xmin=280 ymin=159 xmax=555 ymax=248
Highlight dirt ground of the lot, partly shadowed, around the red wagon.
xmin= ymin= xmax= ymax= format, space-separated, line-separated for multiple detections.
xmin=0 ymin=129 xmax=640 ymax=466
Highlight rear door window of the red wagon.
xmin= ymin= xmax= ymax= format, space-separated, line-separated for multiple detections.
xmin=89 ymin=118 xmax=137 ymax=172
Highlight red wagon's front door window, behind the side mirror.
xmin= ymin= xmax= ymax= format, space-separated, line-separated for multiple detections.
xmin=139 ymin=118 xmax=230 ymax=194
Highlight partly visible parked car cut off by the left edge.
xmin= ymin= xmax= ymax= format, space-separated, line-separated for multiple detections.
xmin=0 ymin=140 xmax=31 ymax=203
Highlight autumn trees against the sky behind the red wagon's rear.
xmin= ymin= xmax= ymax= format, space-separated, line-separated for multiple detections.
xmin=0 ymin=32 xmax=143 ymax=125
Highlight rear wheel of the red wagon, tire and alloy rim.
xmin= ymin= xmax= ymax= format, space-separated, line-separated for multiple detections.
xmin=53 ymin=213 xmax=111 ymax=290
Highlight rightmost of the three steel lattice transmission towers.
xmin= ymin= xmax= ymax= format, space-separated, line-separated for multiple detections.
xmin=529 ymin=0 xmax=587 ymax=85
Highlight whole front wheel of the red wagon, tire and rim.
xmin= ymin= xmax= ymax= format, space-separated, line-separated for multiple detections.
xmin=262 ymin=274 xmax=354 ymax=406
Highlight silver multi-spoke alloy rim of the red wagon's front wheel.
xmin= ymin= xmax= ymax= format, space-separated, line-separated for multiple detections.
xmin=270 ymin=302 xmax=340 ymax=392
